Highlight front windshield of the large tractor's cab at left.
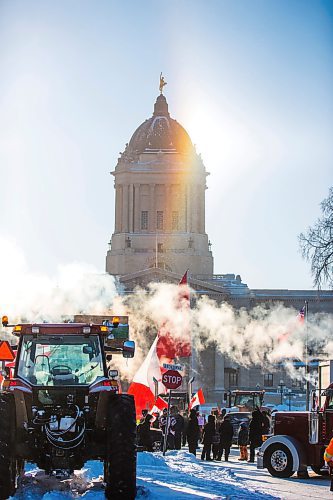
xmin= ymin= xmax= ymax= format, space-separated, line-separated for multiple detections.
xmin=17 ymin=335 xmax=104 ymax=386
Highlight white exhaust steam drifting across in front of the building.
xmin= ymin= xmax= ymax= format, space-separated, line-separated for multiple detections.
xmin=0 ymin=240 xmax=333 ymax=380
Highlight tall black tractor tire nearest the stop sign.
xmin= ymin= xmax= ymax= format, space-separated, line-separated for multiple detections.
xmin=104 ymin=394 xmax=136 ymax=500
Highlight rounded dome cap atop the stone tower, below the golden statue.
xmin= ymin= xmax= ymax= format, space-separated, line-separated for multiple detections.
xmin=126 ymin=94 xmax=194 ymax=154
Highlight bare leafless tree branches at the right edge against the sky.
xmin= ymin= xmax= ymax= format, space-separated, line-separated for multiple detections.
xmin=298 ymin=187 xmax=333 ymax=288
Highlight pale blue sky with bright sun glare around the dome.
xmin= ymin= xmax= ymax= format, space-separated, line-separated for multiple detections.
xmin=0 ymin=0 xmax=333 ymax=289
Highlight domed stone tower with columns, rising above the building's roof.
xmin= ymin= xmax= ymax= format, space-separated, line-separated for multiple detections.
xmin=106 ymin=95 xmax=213 ymax=275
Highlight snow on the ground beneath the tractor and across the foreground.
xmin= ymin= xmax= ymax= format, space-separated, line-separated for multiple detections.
xmin=13 ymin=448 xmax=333 ymax=500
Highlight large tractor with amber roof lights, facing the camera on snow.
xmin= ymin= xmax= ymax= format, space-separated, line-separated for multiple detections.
xmin=0 ymin=317 xmax=136 ymax=500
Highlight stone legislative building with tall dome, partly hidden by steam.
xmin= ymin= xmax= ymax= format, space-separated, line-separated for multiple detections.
xmin=106 ymin=87 xmax=333 ymax=404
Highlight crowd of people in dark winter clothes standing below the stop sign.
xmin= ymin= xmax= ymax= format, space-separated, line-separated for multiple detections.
xmin=137 ymin=406 xmax=271 ymax=462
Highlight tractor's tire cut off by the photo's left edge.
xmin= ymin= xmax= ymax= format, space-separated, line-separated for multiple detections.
xmin=0 ymin=394 xmax=18 ymax=500
